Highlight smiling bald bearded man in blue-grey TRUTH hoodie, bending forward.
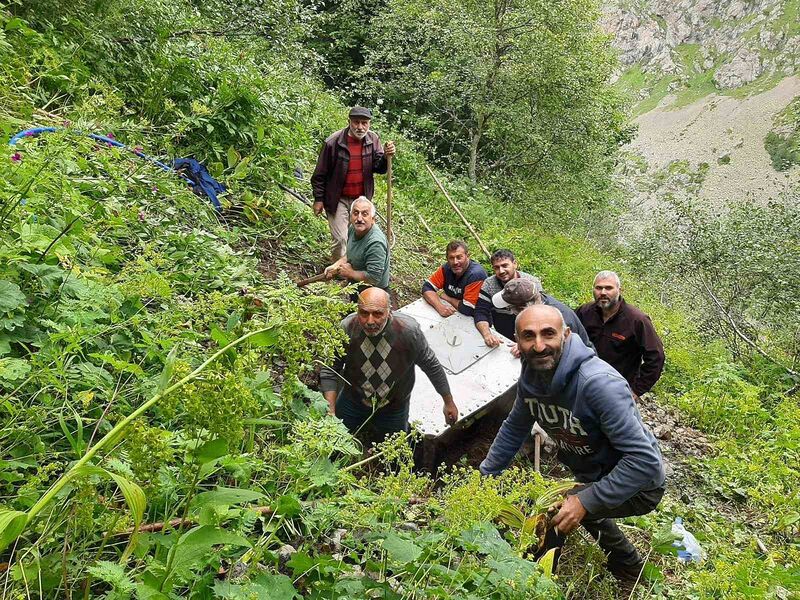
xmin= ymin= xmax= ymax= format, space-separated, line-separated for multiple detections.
xmin=480 ymin=305 xmax=665 ymax=581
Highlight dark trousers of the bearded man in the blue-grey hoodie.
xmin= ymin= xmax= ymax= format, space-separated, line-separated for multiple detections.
xmin=540 ymin=483 xmax=664 ymax=570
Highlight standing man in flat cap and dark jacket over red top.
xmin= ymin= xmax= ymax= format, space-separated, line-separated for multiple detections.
xmin=311 ymin=106 xmax=395 ymax=261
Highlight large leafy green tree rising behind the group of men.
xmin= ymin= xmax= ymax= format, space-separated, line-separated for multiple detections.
xmin=361 ymin=0 xmax=624 ymax=182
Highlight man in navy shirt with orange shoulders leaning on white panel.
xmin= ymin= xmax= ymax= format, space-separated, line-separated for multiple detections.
xmin=422 ymin=240 xmax=486 ymax=317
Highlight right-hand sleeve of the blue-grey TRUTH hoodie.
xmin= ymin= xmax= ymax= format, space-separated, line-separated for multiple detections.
xmin=577 ymin=374 xmax=664 ymax=513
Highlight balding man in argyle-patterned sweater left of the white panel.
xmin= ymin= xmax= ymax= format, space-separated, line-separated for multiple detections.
xmin=320 ymin=288 xmax=458 ymax=441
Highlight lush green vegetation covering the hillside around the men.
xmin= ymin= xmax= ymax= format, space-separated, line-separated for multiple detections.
xmin=0 ymin=0 xmax=800 ymax=600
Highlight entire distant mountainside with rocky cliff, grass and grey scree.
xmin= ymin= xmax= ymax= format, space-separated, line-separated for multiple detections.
xmin=602 ymin=0 xmax=800 ymax=230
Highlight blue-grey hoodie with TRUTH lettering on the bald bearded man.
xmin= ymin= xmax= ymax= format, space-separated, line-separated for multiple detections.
xmin=480 ymin=335 xmax=665 ymax=514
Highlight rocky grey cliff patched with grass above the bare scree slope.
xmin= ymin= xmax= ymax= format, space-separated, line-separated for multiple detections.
xmin=603 ymin=0 xmax=800 ymax=90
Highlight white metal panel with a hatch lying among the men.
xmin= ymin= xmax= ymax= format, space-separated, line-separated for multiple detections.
xmin=399 ymin=299 xmax=520 ymax=437
